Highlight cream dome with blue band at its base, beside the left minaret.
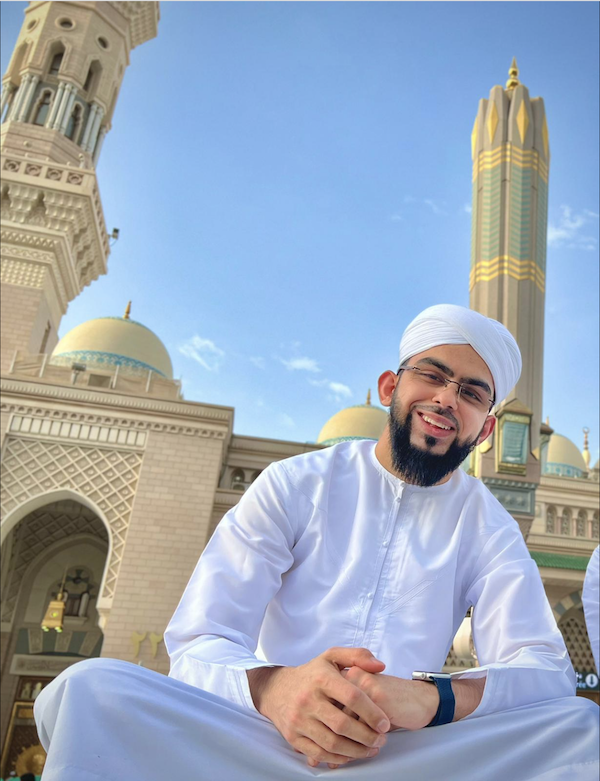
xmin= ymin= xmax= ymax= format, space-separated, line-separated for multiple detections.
xmin=50 ymin=306 xmax=173 ymax=380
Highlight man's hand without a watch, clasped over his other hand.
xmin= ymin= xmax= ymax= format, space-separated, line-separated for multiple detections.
xmin=247 ymin=648 xmax=390 ymax=767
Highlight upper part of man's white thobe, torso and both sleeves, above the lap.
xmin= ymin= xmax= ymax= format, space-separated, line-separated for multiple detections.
xmin=165 ymin=441 xmax=575 ymax=716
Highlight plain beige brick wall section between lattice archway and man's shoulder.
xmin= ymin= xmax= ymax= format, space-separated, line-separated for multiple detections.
xmin=102 ymin=432 xmax=223 ymax=673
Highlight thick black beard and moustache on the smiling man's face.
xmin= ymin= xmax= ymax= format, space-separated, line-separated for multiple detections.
xmin=390 ymin=398 xmax=481 ymax=488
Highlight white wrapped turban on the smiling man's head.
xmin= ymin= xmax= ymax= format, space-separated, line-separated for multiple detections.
xmin=400 ymin=304 xmax=522 ymax=404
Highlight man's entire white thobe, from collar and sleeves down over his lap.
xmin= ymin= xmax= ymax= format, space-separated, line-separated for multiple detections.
xmin=35 ymin=442 xmax=599 ymax=781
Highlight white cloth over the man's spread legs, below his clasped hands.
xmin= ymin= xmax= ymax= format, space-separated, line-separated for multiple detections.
xmin=35 ymin=659 xmax=600 ymax=781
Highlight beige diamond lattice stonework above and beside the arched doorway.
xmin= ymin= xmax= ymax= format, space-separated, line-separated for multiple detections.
xmin=0 ymin=438 xmax=142 ymax=599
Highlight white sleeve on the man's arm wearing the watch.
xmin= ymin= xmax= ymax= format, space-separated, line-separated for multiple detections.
xmin=453 ymin=523 xmax=575 ymax=718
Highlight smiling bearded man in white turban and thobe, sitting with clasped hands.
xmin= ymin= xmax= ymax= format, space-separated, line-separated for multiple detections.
xmin=36 ymin=305 xmax=598 ymax=781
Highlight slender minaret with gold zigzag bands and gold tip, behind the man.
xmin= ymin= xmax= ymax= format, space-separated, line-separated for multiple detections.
xmin=470 ymin=59 xmax=550 ymax=528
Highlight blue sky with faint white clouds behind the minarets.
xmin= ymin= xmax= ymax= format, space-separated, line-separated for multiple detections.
xmin=1 ymin=2 xmax=600 ymax=460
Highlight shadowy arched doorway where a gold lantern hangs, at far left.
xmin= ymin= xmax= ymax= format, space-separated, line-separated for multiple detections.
xmin=0 ymin=493 xmax=110 ymax=777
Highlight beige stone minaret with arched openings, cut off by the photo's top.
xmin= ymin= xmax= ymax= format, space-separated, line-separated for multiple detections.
xmin=0 ymin=2 xmax=159 ymax=373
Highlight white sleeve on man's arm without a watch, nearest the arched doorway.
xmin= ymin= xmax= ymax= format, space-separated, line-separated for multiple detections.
xmin=165 ymin=464 xmax=296 ymax=710
